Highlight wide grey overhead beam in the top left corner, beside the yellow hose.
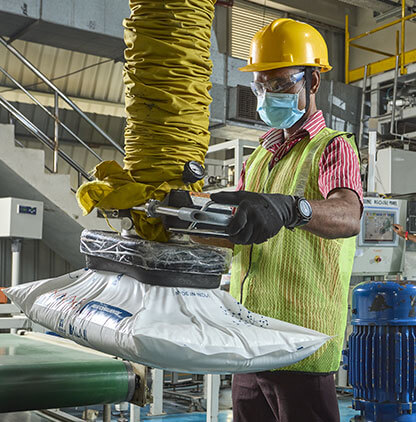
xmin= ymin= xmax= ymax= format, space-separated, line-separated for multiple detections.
xmin=0 ymin=0 xmax=130 ymax=60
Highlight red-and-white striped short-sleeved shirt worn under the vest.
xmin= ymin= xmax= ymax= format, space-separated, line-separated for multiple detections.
xmin=237 ymin=110 xmax=363 ymax=204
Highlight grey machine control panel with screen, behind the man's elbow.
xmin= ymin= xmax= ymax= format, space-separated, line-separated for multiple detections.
xmin=353 ymin=198 xmax=406 ymax=276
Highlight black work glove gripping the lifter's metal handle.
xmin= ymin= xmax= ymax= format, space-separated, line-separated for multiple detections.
xmin=211 ymin=191 xmax=298 ymax=245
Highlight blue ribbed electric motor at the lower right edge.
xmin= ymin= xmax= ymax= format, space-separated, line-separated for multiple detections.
xmin=344 ymin=281 xmax=416 ymax=422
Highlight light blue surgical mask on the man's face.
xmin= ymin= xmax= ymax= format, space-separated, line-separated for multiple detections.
xmin=257 ymin=89 xmax=305 ymax=129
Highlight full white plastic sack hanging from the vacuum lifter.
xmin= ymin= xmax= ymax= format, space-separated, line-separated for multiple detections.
xmin=5 ymin=270 xmax=330 ymax=373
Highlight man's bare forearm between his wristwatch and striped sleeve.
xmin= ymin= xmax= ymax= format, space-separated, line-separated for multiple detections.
xmin=301 ymin=191 xmax=361 ymax=239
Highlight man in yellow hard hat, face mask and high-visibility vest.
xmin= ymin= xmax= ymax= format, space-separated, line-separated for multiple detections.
xmin=211 ymin=19 xmax=363 ymax=422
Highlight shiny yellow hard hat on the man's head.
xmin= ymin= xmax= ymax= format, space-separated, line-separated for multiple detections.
xmin=240 ymin=19 xmax=332 ymax=72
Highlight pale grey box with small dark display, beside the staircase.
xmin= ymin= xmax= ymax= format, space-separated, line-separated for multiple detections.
xmin=0 ymin=198 xmax=43 ymax=239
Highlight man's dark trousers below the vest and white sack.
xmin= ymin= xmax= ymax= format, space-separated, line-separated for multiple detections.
xmin=232 ymin=371 xmax=340 ymax=422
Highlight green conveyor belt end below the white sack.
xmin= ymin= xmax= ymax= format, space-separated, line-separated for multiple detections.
xmin=0 ymin=333 xmax=148 ymax=413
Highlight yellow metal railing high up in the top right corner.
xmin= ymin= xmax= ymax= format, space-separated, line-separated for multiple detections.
xmin=345 ymin=0 xmax=416 ymax=84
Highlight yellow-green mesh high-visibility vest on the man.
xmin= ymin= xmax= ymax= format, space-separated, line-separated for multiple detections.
xmin=230 ymin=128 xmax=358 ymax=373
